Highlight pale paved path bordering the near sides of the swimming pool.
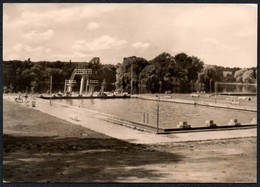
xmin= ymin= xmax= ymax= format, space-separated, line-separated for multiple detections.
xmin=4 ymin=96 xmax=256 ymax=144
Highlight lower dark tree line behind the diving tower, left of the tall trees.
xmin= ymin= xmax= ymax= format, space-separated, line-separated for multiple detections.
xmin=3 ymin=57 xmax=117 ymax=93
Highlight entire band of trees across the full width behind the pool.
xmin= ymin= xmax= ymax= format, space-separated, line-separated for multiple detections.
xmin=3 ymin=53 xmax=257 ymax=93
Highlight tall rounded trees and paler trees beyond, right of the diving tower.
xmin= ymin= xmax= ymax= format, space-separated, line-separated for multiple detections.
xmin=116 ymin=53 xmax=257 ymax=93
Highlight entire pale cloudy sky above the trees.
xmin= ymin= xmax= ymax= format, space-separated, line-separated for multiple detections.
xmin=3 ymin=3 xmax=257 ymax=68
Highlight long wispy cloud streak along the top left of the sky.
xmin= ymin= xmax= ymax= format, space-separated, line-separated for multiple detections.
xmin=4 ymin=4 xmax=115 ymax=28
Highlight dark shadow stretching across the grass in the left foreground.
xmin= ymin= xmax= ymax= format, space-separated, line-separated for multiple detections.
xmin=3 ymin=135 xmax=183 ymax=182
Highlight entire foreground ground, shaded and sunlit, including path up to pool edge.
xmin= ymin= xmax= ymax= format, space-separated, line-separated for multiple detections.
xmin=3 ymin=98 xmax=256 ymax=183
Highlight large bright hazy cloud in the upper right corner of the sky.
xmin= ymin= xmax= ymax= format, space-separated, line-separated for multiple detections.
xmin=175 ymin=4 xmax=255 ymax=30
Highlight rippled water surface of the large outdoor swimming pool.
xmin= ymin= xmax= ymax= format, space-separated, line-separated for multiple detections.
xmin=57 ymin=98 xmax=256 ymax=128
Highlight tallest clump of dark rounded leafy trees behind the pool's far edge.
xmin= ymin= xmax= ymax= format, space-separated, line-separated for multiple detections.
xmin=117 ymin=53 xmax=204 ymax=92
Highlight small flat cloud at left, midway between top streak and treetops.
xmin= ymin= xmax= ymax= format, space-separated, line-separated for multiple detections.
xmin=23 ymin=29 xmax=54 ymax=42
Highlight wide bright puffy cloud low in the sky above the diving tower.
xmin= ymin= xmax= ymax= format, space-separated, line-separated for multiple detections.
xmin=72 ymin=35 xmax=127 ymax=52
